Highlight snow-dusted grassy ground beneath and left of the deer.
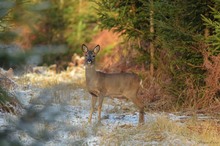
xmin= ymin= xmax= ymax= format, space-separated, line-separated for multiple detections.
xmin=0 ymin=68 xmax=218 ymax=146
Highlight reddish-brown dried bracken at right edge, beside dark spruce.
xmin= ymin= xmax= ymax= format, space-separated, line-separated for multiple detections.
xmin=179 ymin=52 xmax=220 ymax=114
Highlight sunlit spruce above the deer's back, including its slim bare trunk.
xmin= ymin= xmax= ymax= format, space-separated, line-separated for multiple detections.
xmin=96 ymin=0 xmax=155 ymax=75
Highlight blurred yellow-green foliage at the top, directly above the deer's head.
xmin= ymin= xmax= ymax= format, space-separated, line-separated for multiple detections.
xmin=63 ymin=0 xmax=98 ymax=53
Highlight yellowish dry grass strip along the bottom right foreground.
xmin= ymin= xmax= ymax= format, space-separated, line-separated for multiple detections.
xmin=101 ymin=117 xmax=220 ymax=146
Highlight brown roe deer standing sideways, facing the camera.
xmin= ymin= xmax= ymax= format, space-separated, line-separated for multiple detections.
xmin=82 ymin=44 xmax=144 ymax=123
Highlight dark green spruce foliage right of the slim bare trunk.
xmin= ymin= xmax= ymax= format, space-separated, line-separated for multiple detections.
xmin=150 ymin=0 xmax=217 ymax=106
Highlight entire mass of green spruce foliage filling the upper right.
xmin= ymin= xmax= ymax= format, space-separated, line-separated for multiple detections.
xmin=96 ymin=0 xmax=220 ymax=108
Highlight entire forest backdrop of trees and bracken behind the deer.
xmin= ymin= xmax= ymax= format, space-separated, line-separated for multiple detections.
xmin=0 ymin=0 xmax=220 ymax=113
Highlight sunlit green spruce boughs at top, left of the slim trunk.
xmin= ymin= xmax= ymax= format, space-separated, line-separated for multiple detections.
xmin=96 ymin=0 xmax=149 ymax=38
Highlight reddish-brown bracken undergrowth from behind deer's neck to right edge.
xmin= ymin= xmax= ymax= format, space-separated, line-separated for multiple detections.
xmin=100 ymin=46 xmax=220 ymax=114
